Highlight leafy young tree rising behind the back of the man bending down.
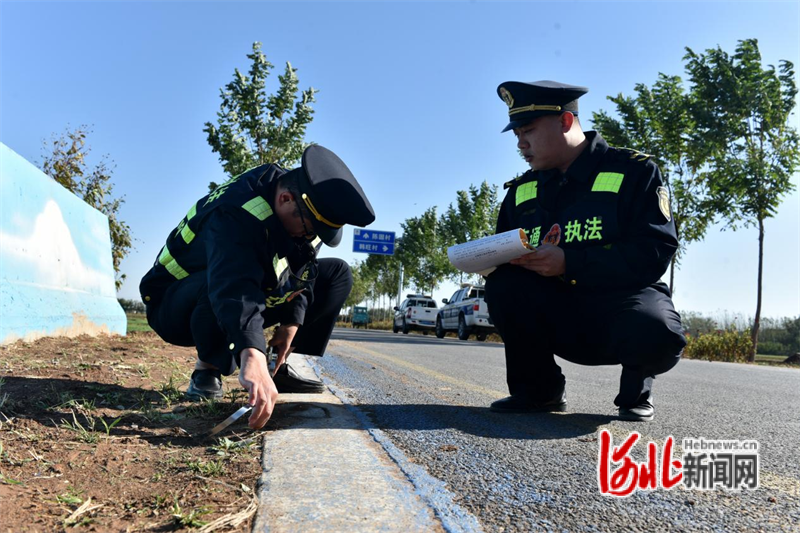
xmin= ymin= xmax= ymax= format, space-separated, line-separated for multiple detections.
xmin=203 ymin=42 xmax=317 ymax=183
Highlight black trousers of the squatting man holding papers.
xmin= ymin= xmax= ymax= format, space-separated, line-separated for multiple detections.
xmin=486 ymin=265 xmax=686 ymax=407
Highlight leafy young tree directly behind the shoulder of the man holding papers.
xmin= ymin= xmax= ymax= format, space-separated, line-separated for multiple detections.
xmin=592 ymin=74 xmax=713 ymax=291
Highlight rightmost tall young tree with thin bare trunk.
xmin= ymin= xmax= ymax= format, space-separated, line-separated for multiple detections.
xmin=684 ymin=39 xmax=800 ymax=361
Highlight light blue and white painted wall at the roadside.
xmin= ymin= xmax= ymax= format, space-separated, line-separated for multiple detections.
xmin=0 ymin=143 xmax=127 ymax=344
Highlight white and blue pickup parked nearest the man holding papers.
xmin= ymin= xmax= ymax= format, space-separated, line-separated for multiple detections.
xmin=435 ymin=283 xmax=496 ymax=341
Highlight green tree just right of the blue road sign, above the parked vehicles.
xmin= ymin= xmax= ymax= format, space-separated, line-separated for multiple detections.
xmin=397 ymin=207 xmax=452 ymax=293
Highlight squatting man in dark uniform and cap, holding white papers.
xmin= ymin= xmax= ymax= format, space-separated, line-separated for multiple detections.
xmin=486 ymin=81 xmax=686 ymax=421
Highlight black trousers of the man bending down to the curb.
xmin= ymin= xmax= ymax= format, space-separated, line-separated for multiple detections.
xmin=147 ymin=258 xmax=353 ymax=375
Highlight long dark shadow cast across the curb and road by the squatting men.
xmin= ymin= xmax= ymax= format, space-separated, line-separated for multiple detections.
xmin=274 ymin=402 xmax=615 ymax=440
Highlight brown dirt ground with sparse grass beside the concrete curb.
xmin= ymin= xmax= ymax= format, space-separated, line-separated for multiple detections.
xmin=0 ymin=332 xmax=280 ymax=532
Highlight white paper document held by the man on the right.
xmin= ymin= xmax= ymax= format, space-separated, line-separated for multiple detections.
xmin=447 ymin=229 xmax=536 ymax=276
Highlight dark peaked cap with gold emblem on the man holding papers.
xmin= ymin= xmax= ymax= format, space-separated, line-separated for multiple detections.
xmin=497 ymin=80 xmax=589 ymax=131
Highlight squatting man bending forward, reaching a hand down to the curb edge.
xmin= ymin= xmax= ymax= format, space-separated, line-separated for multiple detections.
xmin=139 ymin=146 xmax=375 ymax=428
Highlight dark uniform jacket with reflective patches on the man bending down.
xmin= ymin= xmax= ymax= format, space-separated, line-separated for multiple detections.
xmin=139 ymin=165 xmax=313 ymax=358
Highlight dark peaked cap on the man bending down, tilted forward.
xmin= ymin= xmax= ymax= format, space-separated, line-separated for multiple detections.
xmin=291 ymin=145 xmax=375 ymax=246
